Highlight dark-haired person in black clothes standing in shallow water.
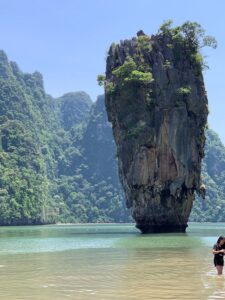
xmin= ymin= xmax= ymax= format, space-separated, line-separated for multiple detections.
xmin=212 ymin=236 xmax=225 ymax=275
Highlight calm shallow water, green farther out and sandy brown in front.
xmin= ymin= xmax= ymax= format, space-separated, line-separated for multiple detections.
xmin=0 ymin=223 xmax=225 ymax=300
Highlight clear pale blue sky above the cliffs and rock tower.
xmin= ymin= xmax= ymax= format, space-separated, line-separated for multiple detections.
xmin=0 ymin=0 xmax=225 ymax=144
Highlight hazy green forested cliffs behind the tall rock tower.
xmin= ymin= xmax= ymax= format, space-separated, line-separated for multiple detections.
xmin=0 ymin=51 xmax=225 ymax=225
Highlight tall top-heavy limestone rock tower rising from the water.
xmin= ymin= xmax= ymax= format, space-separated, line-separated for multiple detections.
xmin=105 ymin=25 xmax=208 ymax=233
